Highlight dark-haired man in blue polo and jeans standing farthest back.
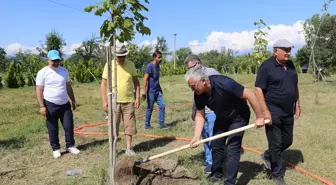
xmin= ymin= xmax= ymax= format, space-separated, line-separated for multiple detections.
xmin=142 ymin=51 xmax=169 ymax=129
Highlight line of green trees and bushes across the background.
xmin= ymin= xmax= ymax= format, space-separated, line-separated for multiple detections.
xmin=0 ymin=13 xmax=336 ymax=88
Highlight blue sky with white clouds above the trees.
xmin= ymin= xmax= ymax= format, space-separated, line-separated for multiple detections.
xmin=0 ymin=0 xmax=336 ymax=54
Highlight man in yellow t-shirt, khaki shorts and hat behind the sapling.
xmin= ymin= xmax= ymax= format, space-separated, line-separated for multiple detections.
xmin=100 ymin=45 xmax=140 ymax=156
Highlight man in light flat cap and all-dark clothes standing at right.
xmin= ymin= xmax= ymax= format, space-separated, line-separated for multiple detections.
xmin=254 ymin=39 xmax=301 ymax=185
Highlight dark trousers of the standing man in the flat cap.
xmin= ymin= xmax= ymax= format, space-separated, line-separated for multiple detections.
xmin=265 ymin=115 xmax=294 ymax=177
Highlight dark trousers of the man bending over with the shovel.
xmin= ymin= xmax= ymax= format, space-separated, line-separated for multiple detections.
xmin=211 ymin=109 xmax=250 ymax=185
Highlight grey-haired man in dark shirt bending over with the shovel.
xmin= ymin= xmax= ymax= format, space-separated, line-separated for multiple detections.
xmin=185 ymin=67 xmax=264 ymax=185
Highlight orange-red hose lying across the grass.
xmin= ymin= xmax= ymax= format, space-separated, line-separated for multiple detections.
xmin=74 ymin=104 xmax=335 ymax=185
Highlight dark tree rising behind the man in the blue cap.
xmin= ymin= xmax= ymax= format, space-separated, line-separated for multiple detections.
xmin=36 ymin=30 xmax=66 ymax=57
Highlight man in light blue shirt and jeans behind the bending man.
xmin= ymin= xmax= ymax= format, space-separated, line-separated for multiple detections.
xmin=184 ymin=54 xmax=220 ymax=173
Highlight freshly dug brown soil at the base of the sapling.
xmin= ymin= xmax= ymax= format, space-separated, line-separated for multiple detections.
xmin=116 ymin=158 xmax=197 ymax=185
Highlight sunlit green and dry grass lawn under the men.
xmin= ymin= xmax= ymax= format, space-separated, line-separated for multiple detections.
xmin=0 ymin=75 xmax=336 ymax=185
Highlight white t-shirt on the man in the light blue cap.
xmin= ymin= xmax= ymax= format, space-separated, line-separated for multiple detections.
xmin=36 ymin=66 xmax=70 ymax=105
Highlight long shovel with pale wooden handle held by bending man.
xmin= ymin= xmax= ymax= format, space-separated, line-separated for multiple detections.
xmin=134 ymin=120 xmax=270 ymax=165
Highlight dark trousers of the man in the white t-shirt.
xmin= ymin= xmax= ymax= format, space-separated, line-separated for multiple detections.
xmin=44 ymin=100 xmax=75 ymax=151
